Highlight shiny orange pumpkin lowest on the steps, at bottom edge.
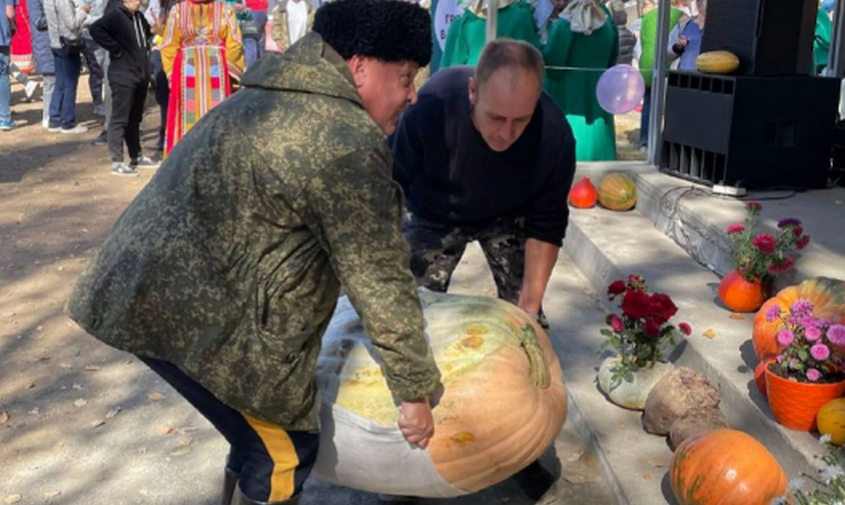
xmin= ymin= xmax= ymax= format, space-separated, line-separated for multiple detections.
xmin=669 ymin=428 xmax=787 ymax=505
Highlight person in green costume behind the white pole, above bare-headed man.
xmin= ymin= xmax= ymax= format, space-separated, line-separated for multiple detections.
xmin=440 ymin=0 xmax=540 ymax=68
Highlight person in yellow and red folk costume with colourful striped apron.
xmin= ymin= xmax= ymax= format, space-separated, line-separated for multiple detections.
xmin=161 ymin=0 xmax=244 ymax=156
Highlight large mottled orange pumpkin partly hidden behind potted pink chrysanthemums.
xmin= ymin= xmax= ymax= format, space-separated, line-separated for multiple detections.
xmin=752 ymin=277 xmax=845 ymax=361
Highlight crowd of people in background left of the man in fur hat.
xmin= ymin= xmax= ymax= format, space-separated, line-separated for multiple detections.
xmin=0 ymin=0 xmax=315 ymax=176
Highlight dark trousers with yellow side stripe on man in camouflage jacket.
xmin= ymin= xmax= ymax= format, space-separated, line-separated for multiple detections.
xmin=140 ymin=358 xmax=320 ymax=503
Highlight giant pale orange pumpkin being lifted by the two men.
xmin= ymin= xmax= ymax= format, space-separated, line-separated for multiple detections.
xmin=315 ymin=290 xmax=567 ymax=497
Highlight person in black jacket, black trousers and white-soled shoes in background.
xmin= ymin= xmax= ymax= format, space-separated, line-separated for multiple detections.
xmin=90 ymin=0 xmax=158 ymax=176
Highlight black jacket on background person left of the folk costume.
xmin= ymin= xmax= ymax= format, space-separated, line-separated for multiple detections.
xmin=90 ymin=2 xmax=152 ymax=87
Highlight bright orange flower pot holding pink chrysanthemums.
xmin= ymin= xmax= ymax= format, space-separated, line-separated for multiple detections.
xmin=766 ymin=367 xmax=845 ymax=431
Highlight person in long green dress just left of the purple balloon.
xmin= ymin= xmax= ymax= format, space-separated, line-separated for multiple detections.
xmin=543 ymin=0 xmax=619 ymax=161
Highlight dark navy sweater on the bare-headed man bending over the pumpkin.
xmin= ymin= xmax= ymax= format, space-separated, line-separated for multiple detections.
xmin=392 ymin=67 xmax=575 ymax=246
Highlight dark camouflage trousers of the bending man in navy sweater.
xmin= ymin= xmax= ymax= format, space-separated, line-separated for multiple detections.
xmin=402 ymin=212 xmax=526 ymax=303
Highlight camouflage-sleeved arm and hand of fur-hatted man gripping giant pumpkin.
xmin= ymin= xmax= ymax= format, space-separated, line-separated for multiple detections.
xmin=304 ymin=145 xmax=440 ymax=447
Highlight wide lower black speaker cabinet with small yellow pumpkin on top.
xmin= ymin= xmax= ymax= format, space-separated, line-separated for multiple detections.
xmin=660 ymin=72 xmax=839 ymax=189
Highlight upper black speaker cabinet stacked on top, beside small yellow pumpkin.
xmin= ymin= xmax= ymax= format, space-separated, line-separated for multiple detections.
xmin=701 ymin=0 xmax=818 ymax=76
